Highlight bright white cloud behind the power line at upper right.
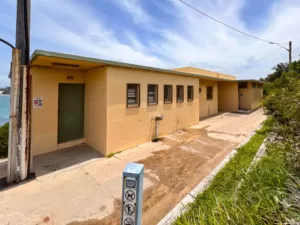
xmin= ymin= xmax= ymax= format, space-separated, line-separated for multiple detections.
xmin=151 ymin=0 xmax=300 ymax=78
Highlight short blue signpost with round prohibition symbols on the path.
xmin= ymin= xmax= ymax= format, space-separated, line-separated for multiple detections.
xmin=121 ymin=163 xmax=144 ymax=225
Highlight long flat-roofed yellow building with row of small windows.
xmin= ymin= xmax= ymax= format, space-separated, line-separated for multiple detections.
xmin=30 ymin=50 xmax=262 ymax=155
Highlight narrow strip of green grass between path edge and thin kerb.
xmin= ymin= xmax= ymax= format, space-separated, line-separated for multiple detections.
xmin=174 ymin=117 xmax=273 ymax=225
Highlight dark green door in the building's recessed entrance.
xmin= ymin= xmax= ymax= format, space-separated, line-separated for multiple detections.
xmin=58 ymin=84 xmax=84 ymax=143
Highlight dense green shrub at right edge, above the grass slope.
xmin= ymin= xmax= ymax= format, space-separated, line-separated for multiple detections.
xmin=264 ymin=70 xmax=300 ymax=174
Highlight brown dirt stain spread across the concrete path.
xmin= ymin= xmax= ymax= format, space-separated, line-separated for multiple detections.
xmin=69 ymin=128 xmax=241 ymax=225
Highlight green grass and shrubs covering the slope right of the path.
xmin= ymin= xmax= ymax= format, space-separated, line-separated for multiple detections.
xmin=174 ymin=61 xmax=300 ymax=225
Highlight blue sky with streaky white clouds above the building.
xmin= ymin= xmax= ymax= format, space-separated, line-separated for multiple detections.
xmin=0 ymin=0 xmax=300 ymax=87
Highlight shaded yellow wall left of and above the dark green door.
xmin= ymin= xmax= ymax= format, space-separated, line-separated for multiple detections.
xmin=30 ymin=66 xmax=85 ymax=155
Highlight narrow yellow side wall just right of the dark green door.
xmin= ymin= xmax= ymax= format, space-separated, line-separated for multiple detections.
xmin=84 ymin=67 xmax=107 ymax=154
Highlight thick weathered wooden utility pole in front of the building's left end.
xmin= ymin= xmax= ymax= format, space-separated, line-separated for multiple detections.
xmin=7 ymin=0 xmax=31 ymax=183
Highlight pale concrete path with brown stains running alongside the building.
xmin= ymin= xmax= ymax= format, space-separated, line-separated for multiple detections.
xmin=0 ymin=110 xmax=265 ymax=225
